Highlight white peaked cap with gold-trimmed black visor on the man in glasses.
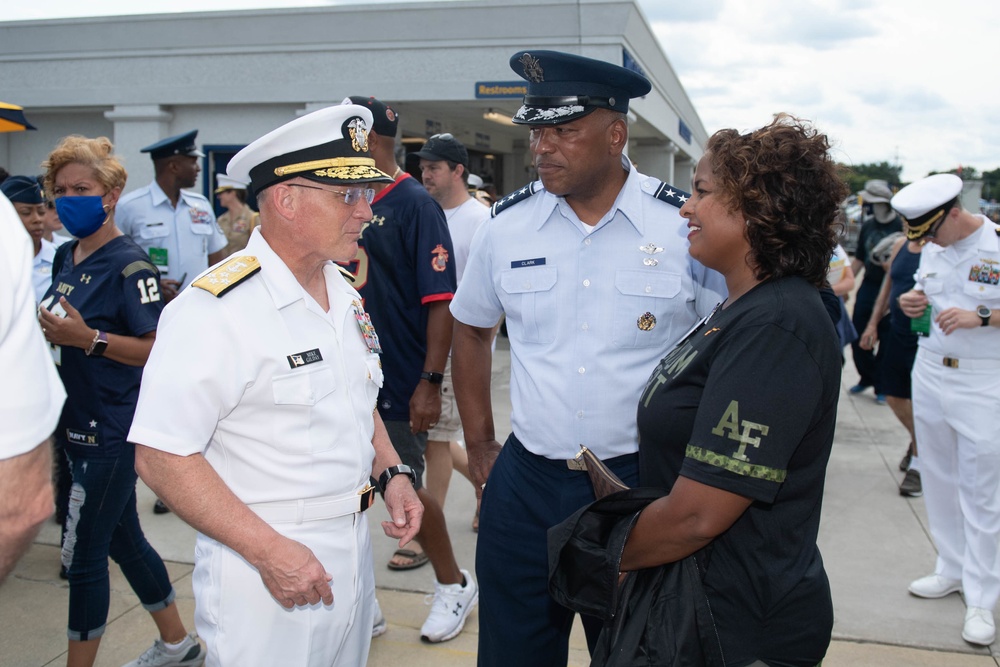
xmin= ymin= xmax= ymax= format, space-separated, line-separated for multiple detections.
xmin=226 ymin=104 xmax=392 ymax=194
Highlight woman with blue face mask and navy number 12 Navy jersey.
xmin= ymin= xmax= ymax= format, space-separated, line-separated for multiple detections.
xmin=38 ymin=135 xmax=204 ymax=667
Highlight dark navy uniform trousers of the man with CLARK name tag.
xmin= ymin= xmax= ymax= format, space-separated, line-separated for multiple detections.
xmin=476 ymin=434 xmax=638 ymax=667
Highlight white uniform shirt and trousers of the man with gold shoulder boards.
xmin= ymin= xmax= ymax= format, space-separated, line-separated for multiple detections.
xmin=129 ymin=229 xmax=382 ymax=667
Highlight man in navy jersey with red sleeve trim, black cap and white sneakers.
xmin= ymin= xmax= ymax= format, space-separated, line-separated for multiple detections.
xmin=344 ymin=96 xmax=479 ymax=642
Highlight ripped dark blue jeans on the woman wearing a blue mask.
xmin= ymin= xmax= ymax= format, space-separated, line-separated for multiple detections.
xmin=62 ymin=445 xmax=174 ymax=641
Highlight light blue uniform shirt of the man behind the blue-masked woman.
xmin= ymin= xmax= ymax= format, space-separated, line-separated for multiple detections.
xmin=115 ymin=181 xmax=228 ymax=287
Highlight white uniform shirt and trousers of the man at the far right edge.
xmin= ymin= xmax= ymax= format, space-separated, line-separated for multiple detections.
xmin=913 ymin=216 xmax=1000 ymax=609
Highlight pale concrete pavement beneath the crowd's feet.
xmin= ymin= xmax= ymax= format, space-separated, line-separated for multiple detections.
xmin=0 ymin=339 xmax=1000 ymax=667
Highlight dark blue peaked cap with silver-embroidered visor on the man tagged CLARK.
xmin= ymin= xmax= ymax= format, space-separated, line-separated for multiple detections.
xmin=510 ymin=51 xmax=652 ymax=125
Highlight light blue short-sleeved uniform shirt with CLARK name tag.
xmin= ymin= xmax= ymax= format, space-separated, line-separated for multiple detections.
xmin=451 ymin=159 xmax=725 ymax=459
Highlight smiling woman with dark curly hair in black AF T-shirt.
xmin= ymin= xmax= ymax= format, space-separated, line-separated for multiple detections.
xmin=620 ymin=114 xmax=846 ymax=666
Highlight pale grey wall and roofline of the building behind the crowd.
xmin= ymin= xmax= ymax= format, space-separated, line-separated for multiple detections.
xmin=0 ymin=0 xmax=706 ymax=197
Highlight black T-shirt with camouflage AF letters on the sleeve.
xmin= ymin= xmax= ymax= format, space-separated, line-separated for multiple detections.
xmin=638 ymin=277 xmax=840 ymax=665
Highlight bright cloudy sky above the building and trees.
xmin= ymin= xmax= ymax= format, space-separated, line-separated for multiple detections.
xmin=0 ymin=0 xmax=1000 ymax=181
